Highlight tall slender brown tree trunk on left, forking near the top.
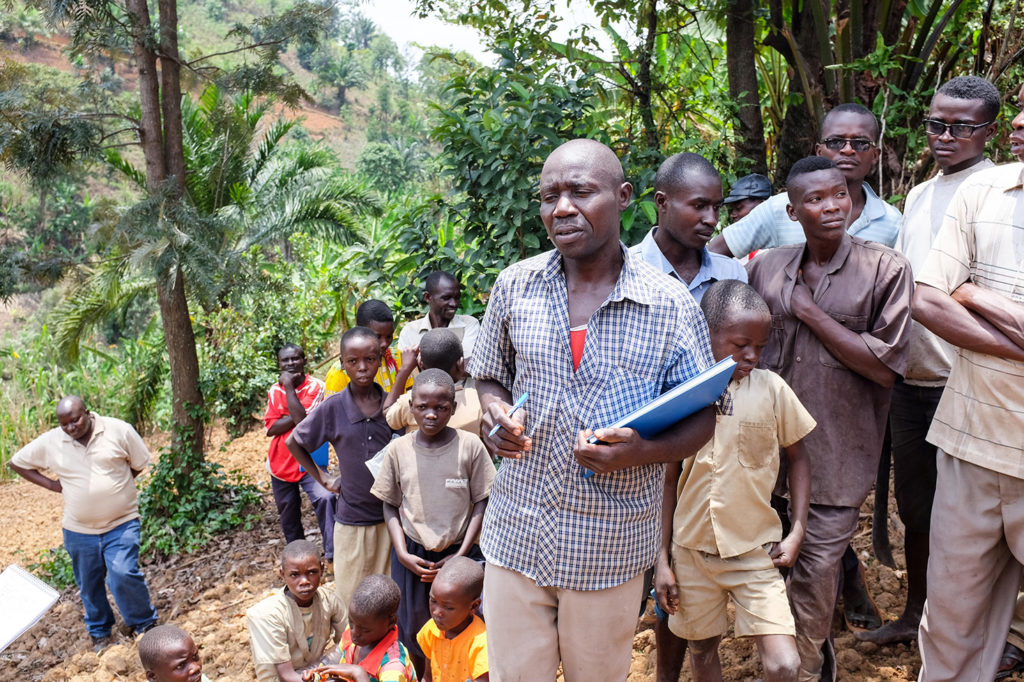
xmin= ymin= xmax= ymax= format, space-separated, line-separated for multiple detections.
xmin=126 ymin=0 xmax=203 ymax=457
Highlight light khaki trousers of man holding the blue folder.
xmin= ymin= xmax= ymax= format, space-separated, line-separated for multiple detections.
xmin=483 ymin=561 xmax=643 ymax=682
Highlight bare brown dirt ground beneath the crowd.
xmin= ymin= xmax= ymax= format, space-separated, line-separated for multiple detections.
xmin=0 ymin=421 xmax=1019 ymax=682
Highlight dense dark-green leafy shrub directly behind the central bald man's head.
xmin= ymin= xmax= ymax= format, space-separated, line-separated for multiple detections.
xmin=431 ymin=38 xmax=600 ymax=267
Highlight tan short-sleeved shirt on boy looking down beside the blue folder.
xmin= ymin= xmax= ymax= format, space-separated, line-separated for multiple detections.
xmin=672 ymin=370 xmax=814 ymax=558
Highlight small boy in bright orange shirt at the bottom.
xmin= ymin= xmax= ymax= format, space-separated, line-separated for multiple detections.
xmin=416 ymin=556 xmax=490 ymax=682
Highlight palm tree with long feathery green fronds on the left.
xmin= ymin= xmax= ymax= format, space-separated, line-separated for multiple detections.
xmin=54 ymin=86 xmax=382 ymax=368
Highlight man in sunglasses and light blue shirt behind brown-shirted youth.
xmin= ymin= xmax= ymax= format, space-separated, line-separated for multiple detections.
xmin=708 ymin=103 xmax=902 ymax=257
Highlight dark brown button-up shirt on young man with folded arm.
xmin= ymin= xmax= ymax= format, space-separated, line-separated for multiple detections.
xmin=746 ymin=235 xmax=913 ymax=507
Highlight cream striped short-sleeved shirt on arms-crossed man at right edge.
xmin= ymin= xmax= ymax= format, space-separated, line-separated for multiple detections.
xmin=918 ymin=163 xmax=1024 ymax=478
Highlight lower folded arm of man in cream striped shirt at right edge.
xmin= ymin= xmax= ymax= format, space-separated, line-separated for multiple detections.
xmin=911 ymin=284 xmax=1024 ymax=361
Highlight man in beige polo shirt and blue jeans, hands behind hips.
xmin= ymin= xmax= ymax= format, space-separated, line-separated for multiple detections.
xmin=8 ymin=395 xmax=157 ymax=651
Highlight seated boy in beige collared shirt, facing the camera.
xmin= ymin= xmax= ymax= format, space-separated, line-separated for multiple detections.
xmin=246 ymin=540 xmax=346 ymax=682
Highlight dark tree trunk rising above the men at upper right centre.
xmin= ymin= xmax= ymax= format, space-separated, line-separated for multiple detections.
xmin=725 ymin=0 xmax=768 ymax=174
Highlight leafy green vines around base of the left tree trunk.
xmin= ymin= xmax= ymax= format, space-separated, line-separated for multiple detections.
xmin=138 ymin=439 xmax=260 ymax=556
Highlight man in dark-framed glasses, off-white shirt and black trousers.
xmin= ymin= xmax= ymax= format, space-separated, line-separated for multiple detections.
xmin=855 ymin=76 xmax=1000 ymax=644
